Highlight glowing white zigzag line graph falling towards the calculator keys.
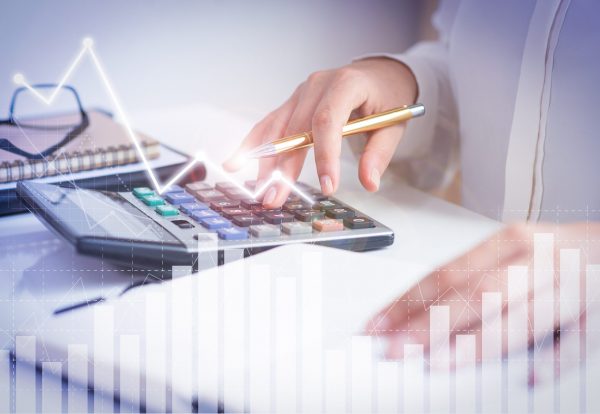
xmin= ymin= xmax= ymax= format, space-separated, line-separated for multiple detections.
xmin=13 ymin=38 xmax=314 ymax=204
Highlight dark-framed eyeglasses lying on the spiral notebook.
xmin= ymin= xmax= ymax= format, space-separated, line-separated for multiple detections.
xmin=0 ymin=83 xmax=90 ymax=160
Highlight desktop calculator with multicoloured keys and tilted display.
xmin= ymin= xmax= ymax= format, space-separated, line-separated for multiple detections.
xmin=17 ymin=181 xmax=394 ymax=270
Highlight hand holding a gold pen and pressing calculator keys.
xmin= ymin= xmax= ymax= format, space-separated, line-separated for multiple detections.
xmin=224 ymin=58 xmax=417 ymax=208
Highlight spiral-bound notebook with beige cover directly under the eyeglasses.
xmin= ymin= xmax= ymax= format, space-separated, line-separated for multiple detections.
xmin=0 ymin=111 xmax=160 ymax=183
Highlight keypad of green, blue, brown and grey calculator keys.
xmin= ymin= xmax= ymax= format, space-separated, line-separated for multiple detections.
xmin=132 ymin=180 xmax=384 ymax=240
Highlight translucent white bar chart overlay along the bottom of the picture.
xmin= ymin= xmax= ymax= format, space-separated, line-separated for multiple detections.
xmin=7 ymin=234 xmax=600 ymax=413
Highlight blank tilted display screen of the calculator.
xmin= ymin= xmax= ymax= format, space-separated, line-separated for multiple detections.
xmin=41 ymin=186 xmax=181 ymax=245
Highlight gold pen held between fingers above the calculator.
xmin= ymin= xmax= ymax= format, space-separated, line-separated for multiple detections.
xmin=246 ymin=104 xmax=425 ymax=158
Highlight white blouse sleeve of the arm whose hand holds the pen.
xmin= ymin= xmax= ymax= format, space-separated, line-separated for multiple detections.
xmin=352 ymin=0 xmax=459 ymax=190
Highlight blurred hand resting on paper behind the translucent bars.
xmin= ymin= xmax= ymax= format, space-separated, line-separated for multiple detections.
xmin=367 ymin=223 xmax=600 ymax=366
